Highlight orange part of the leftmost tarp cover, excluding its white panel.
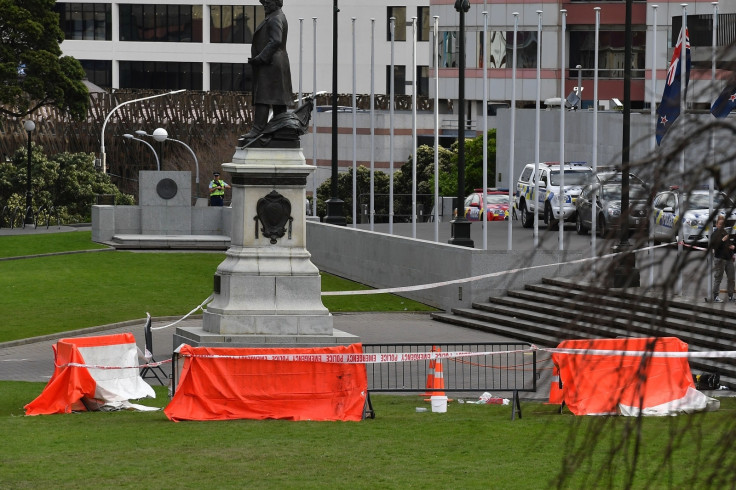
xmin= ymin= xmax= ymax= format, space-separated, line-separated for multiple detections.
xmin=25 ymin=333 xmax=143 ymax=415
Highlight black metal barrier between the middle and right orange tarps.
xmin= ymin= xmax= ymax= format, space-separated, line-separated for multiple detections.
xmin=363 ymin=342 xmax=537 ymax=420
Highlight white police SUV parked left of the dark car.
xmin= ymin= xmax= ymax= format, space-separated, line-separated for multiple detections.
xmin=514 ymin=162 xmax=593 ymax=229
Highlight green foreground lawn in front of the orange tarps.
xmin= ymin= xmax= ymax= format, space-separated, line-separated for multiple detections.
xmin=0 ymin=382 xmax=736 ymax=489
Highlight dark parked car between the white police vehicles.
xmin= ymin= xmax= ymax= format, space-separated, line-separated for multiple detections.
xmin=575 ymin=183 xmax=649 ymax=237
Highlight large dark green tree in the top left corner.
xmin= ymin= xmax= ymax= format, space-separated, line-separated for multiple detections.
xmin=0 ymin=0 xmax=89 ymax=119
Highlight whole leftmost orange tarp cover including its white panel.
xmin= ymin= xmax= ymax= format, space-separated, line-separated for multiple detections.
xmin=25 ymin=333 xmax=155 ymax=415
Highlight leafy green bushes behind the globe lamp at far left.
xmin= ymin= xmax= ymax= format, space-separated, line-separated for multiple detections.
xmin=0 ymin=144 xmax=135 ymax=223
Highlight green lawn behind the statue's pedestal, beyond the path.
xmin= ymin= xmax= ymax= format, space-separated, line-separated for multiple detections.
xmin=0 ymin=232 xmax=433 ymax=342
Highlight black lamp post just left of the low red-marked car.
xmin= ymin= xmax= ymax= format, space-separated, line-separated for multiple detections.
xmin=448 ymin=0 xmax=474 ymax=248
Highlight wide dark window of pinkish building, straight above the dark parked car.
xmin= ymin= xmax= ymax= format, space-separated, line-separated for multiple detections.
xmin=568 ymin=30 xmax=647 ymax=78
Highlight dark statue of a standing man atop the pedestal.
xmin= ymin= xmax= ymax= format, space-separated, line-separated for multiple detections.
xmin=241 ymin=0 xmax=294 ymax=140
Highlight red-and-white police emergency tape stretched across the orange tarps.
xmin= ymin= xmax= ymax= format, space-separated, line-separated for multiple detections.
xmin=56 ymin=344 xmax=736 ymax=369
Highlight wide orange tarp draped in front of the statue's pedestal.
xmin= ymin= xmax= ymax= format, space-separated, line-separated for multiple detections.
xmin=164 ymin=344 xmax=368 ymax=421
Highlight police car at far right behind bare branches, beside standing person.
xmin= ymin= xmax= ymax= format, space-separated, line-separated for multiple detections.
xmin=652 ymin=187 xmax=736 ymax=244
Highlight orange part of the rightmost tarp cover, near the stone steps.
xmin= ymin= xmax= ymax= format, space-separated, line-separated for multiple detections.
xmin=552 ymin=337 xmax=695 ymax=415
